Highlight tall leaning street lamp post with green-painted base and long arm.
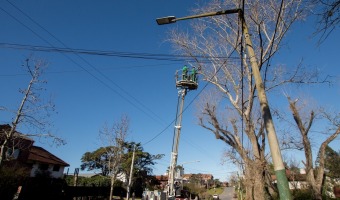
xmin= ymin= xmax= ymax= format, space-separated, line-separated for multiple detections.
xmin=156 ymin=9 xmax=292 ymax=200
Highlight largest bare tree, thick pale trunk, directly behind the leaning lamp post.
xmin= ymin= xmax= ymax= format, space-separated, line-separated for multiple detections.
xmin=169 ymin=0 xmax=318 ymax=199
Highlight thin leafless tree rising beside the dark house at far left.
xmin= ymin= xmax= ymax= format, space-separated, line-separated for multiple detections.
xmin=0 ymin=59 xmax=65 ymax=166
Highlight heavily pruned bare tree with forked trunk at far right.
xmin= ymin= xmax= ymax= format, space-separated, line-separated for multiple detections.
xmin=288 ymin=97 xmax=340 ymax=199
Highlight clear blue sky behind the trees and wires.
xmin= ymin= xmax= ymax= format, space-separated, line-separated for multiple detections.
xmin=0 ymin=0 xmax=340 ymax=181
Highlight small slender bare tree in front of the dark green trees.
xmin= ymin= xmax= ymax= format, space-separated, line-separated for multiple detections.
xmin=99 ymin=116 xmax=129 ymax=200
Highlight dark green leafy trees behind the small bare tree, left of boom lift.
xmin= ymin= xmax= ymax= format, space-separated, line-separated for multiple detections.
xmin=80 ymin=142 xmax=164 ymax=197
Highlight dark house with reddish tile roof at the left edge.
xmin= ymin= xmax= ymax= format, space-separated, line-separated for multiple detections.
xmin=0 ymin=124 xmax=70 ymax=178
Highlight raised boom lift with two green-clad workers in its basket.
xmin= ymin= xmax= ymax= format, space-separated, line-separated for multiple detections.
xmin=168 ymin=66 xmax=198 ymax=198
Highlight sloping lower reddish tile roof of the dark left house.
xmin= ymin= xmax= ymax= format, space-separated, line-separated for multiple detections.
xmin=28 ymin=146 xmax=70 ymax=167
